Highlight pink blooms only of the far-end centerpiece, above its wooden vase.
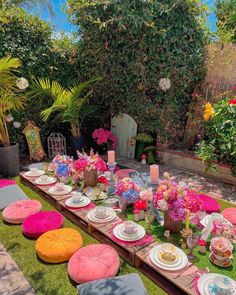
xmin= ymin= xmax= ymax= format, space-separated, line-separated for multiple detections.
xmin=73 ymin=150 xmax=107 ymax=172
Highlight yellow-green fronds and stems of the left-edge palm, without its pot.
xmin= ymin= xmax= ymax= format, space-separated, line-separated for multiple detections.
xmin=0 ymin=57 xmax=27 ymax=146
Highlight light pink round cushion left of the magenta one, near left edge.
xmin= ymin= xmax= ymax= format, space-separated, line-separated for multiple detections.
xmin=2 ymin=200 xmax=42 ymax=224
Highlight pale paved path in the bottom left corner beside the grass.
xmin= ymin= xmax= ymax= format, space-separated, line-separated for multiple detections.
xmin=0 ymin=243 xmax=35 ymax=295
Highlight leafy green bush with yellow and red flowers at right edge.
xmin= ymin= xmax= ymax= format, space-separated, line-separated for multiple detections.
xmin=196 ymin=97 xmax=236 ymax=175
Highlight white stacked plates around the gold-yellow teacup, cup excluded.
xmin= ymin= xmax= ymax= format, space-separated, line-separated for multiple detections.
xmin=149 ymin=245 xmax=188 ymax=271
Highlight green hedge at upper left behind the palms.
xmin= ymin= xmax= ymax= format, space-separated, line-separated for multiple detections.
xmin=0 ymin=8 xmax=78 ymax=154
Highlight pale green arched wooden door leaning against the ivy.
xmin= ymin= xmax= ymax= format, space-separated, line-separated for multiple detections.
xmin=111 ymin=113 xmax=137 ymax=159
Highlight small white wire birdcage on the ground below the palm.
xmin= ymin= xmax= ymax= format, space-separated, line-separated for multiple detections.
xmin=48 ymin=133 xmax=66 ymax=158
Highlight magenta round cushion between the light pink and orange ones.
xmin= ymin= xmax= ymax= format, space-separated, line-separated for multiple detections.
xmin=22 ymin=211 xmax=63 ymax=239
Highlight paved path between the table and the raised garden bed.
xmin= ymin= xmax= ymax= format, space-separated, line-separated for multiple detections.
xmin=116 ymin=156 xmax=236 ymax=204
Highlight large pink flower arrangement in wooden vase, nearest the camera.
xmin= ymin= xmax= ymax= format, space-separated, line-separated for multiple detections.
xmin=153 ymin=172 xmax=201 ymax=232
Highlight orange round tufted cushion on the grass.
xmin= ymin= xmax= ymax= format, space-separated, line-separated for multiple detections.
xmin=36 ymin=228 xmax=82 ymax=263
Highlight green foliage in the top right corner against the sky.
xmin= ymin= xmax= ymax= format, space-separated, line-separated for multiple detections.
xmin=215 ymin=0 xmax=236 ymax=43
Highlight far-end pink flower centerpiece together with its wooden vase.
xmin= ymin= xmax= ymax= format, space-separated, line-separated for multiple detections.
xmin=73 ymin=150 xmax=107 ymax=187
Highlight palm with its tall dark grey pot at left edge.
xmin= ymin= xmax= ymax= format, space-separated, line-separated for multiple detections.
xmin=0 ymin=57 xmax=29 ymax=177
